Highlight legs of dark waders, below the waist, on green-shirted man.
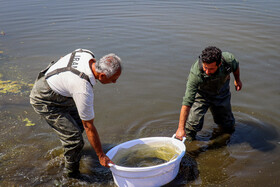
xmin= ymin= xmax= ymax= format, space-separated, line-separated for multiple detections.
xmin=186 ymin=80 xmax=235 ymax=139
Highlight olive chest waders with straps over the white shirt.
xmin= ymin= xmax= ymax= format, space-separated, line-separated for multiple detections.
xmin=30 ymin=51 xmax=94 ymax=176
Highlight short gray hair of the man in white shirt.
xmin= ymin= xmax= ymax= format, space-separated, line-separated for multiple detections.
xmin=95 ymin=53 xmax=122 ymax=78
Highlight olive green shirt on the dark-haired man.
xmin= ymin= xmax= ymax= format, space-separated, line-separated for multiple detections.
xmin=182 ymin=52 xmax=239 ymax=106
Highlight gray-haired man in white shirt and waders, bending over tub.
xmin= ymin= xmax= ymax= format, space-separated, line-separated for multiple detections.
xmin=30 ymin=49 xmax=122 ymax=178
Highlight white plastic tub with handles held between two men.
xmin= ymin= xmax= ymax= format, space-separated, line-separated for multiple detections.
xmin=107 ymin=135 xmax=186 ymax=187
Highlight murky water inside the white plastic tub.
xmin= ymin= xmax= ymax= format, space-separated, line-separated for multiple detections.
xmin=112 ymin=142 xmax=179 ymax=167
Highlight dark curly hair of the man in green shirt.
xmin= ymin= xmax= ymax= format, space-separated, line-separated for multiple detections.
xmin=201 ymin=46 xmax=222 ymax=66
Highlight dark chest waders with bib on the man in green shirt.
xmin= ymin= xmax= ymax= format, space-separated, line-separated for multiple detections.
xmin=186 ymin=58 xmax=235 ymax=139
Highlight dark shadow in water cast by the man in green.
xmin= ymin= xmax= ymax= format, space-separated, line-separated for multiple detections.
xmin=186 ymin=121 xmax=279 ymax=157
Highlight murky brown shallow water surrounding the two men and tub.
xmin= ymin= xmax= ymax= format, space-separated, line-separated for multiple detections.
xmin=0 ymin=0 xmax=280 ymax=186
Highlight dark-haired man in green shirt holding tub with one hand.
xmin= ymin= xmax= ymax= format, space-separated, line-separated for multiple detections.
xmin=176 ymin=46 xmax=242 ymax=141
